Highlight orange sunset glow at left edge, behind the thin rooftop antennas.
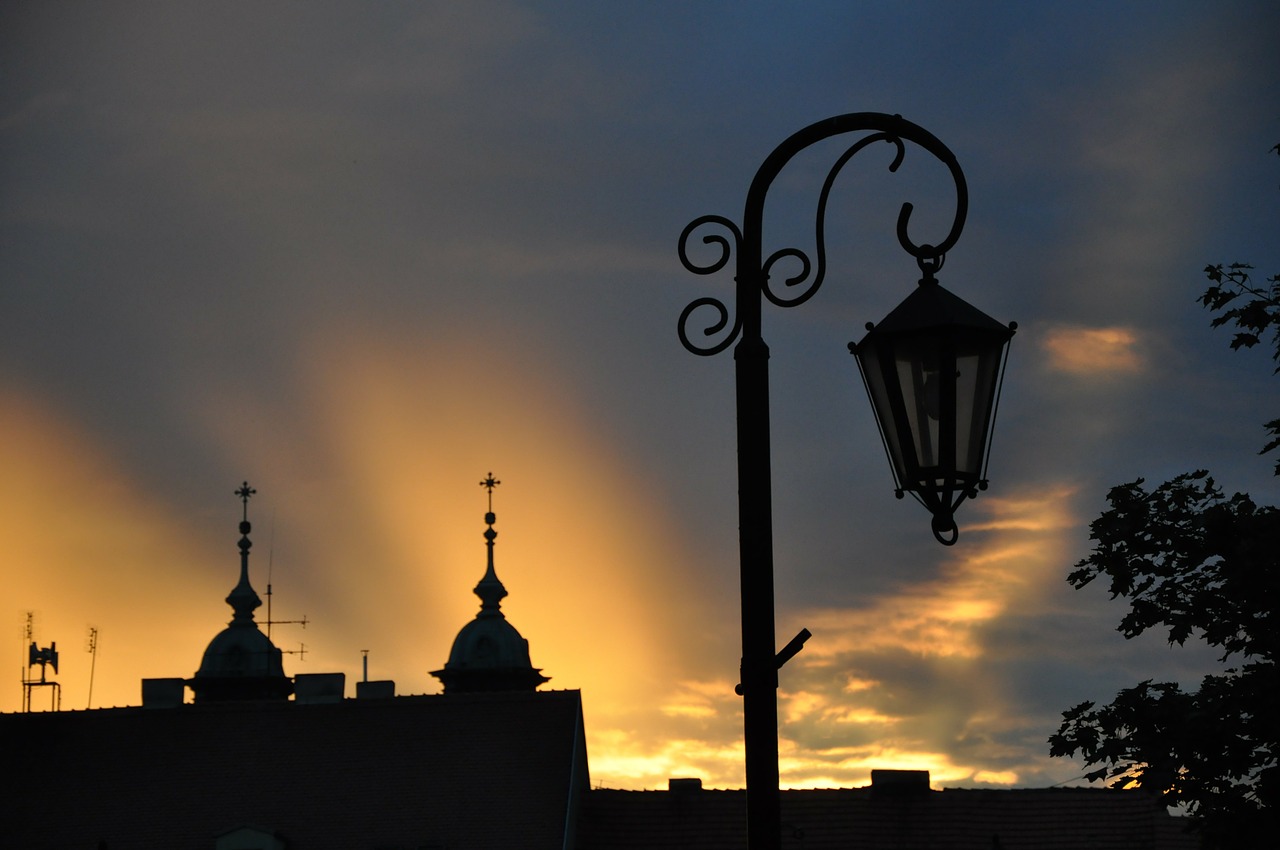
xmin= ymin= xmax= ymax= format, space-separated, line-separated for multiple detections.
xmin=0 ymin=390 xmax=227 ymax=712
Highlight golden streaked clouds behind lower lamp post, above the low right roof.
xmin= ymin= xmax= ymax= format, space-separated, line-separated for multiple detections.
xmin=588 ymin=484 xmax=1090 ymax=789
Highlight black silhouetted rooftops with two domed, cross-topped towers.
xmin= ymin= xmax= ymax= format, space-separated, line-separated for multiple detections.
xmin=0 ymin=474 xmax=1197 ymax=850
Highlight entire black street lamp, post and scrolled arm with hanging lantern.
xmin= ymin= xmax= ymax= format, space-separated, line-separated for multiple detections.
xmin=677 ymin=113 xmax=1016 ymax=850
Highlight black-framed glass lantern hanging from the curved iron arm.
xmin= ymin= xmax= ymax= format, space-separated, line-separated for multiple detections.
xmin=849 ymin=270 xmax=1018 ymax=545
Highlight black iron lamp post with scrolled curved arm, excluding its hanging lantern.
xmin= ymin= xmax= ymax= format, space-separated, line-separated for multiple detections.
xmin=678 ymin=113 xmax=1012 ymax=850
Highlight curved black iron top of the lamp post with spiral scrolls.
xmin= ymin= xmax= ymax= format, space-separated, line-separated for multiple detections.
xmin=677 ymin=113 xmax=969 ymax=357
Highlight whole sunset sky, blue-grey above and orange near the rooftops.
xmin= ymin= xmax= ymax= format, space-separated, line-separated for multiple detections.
xmin=0 ymin=0 xmax=1280 ymax=789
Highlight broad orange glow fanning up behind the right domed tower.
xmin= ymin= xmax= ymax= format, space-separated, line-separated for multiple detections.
xmin=277 ymin=318 xmax=711 ymax=709
